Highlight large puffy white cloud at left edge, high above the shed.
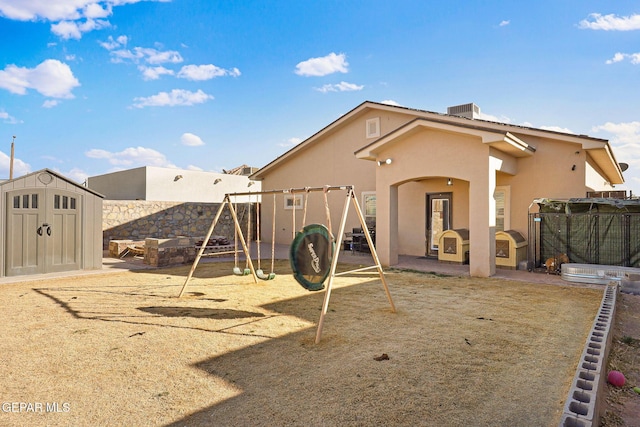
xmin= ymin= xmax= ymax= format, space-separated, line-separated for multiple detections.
xmin=0 ymin=59 xmax=80 ymax=99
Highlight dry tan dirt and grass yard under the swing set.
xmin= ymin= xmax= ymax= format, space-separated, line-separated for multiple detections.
xmin=0 ymin=261 xmax=602 ymax=426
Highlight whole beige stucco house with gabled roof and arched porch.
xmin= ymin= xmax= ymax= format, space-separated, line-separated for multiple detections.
xmin=251 ymin=101 xmax=624 ymax=277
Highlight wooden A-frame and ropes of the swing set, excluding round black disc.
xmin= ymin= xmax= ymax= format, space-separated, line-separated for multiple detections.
xmin=178 ymin=185 xmax=396 ymax=344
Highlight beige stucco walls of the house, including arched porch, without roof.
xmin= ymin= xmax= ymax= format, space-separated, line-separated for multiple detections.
xmin=256 ymin=103 xmax=620 ymax=275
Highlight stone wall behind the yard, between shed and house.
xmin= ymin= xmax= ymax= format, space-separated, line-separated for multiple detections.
xmin=102 ymin=200 xmax=256 ymax=250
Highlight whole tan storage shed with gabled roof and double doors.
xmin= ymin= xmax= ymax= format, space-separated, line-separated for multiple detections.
xmin=0 ymin=169 xmax=103 ymax=277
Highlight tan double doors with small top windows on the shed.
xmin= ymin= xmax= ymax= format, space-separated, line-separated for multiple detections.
xmin=5 ymin=189 xmax=82 ymax=276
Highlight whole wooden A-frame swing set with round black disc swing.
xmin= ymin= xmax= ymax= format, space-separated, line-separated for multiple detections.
xmin=178 ymin=185 xmax=396 ymax=344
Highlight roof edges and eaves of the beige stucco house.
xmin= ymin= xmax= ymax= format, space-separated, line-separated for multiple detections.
xmin=251 ymin=101 xmax=624 ymax=184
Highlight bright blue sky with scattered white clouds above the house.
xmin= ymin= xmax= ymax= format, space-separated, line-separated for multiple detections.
xmin=0 ymin=0 xmax=640 ymax=196
